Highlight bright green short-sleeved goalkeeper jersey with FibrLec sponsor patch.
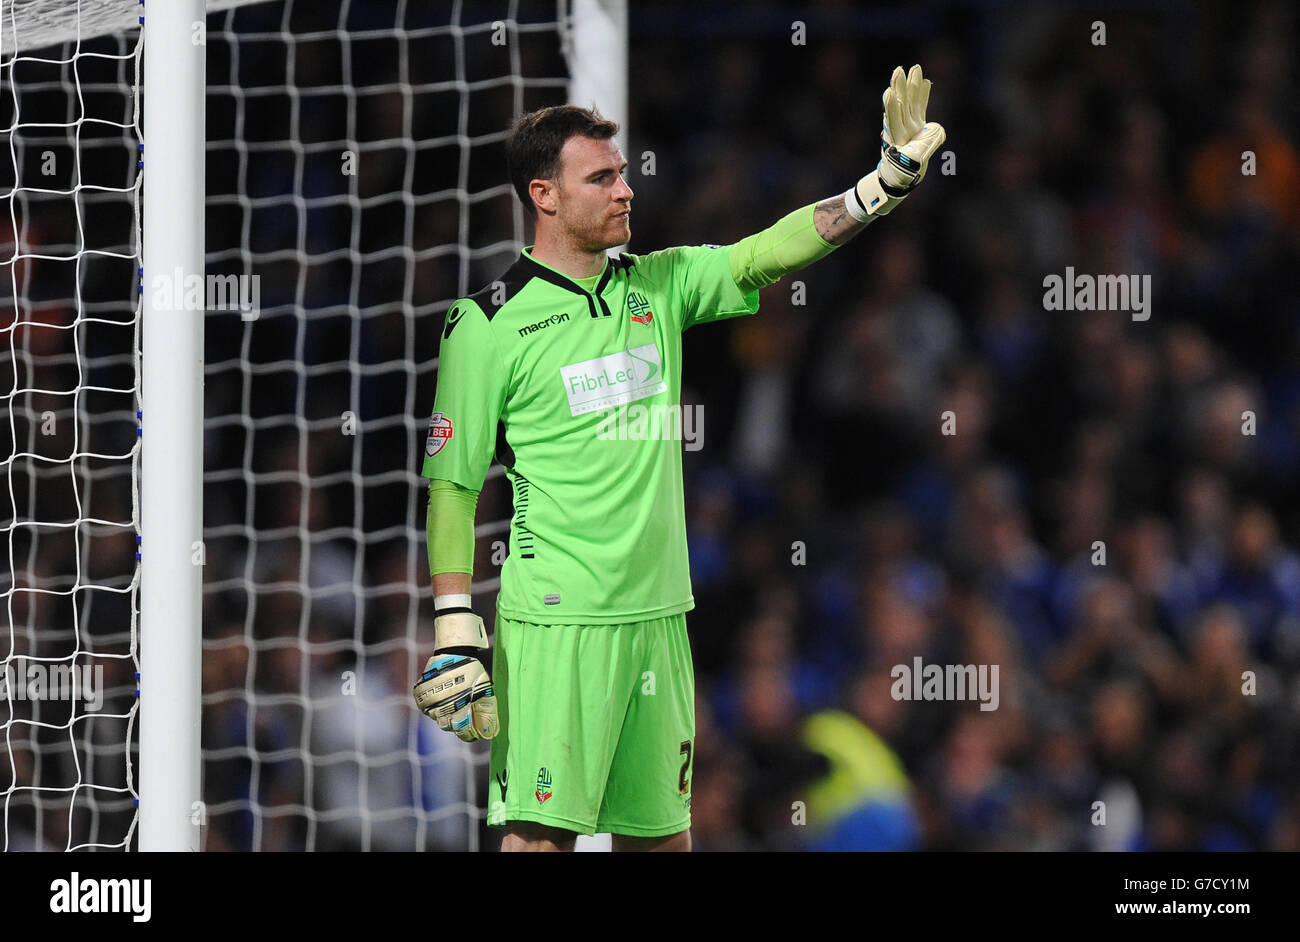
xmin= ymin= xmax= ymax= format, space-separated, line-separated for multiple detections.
xmin=423 ymin=246 xmax=758 ymax=625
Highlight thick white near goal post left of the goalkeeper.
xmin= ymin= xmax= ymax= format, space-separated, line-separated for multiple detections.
xmin=139 ymin=0 xmax=207 ymax=851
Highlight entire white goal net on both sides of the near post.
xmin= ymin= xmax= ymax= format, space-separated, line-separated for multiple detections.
xmin=0 ymin=0 xmax=592 ymax=850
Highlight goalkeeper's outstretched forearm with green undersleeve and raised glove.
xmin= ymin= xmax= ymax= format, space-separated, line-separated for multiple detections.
xmin=729 ymin=65 xmax=946 ymax=292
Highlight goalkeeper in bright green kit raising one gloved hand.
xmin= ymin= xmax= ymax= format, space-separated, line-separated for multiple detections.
xmin=415 ymin=66 xmax=944 ymax=850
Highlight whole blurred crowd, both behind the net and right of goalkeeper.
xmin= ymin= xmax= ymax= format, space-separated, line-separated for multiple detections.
xmin=10 ymin=0 xmax=1300 ymax=850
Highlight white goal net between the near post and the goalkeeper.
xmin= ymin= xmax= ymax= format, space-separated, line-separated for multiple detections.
xmin=203 ymin=0 xmax=567 ymax=850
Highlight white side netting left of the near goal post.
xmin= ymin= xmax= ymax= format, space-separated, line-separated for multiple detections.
xmin=0 ymin=4 xmax=139 ymax=850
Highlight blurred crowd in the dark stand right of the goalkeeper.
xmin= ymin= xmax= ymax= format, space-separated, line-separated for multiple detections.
xmin=642 ymin=4 xmax=1300 ymax=850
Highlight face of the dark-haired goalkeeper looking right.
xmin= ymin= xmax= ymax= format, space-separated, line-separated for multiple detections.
xmin=553 ymin=135 xmax=632 ymax=252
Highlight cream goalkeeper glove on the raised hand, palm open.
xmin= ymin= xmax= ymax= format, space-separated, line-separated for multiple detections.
xmin=845 ymin=65 xmax=948 ymax=222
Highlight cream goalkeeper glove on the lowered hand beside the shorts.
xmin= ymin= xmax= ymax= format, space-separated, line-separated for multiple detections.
xmin=412 ymin=608 xmax=501 ymax=742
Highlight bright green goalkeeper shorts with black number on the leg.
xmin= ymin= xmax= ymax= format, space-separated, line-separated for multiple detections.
xmin=488 ymin=613 xmax=696 ymax=837
